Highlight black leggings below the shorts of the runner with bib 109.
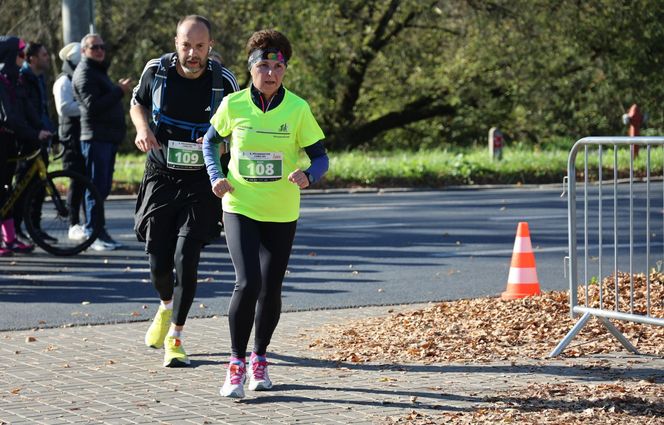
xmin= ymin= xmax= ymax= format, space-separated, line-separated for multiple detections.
xmin=149 ymin=237 xmax=203 ymax=326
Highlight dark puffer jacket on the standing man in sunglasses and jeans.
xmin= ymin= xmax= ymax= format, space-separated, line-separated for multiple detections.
xmin=72 ymin=57 xmax=127 ymax=144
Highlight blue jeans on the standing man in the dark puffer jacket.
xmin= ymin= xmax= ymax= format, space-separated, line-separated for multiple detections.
xmin=81 ymin=140 xmax=118 ymax=229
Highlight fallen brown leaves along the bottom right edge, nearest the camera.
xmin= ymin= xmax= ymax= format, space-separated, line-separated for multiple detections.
xmin=384 ymin=381 xmax=664 ymax=425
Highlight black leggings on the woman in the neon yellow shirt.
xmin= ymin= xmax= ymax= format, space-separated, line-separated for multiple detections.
xmin=224 ymin=212 xmax=297 ymax=358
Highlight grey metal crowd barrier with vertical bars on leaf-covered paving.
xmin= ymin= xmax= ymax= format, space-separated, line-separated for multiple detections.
xmin=549 ymin=137 xmax=664 ymax=357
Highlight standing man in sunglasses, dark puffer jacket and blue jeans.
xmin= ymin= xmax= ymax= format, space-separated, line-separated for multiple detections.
xmin=72 ymin=34 xmax=131 ymax=251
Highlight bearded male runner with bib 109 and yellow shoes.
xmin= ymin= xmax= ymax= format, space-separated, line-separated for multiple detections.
xmin=130 ymin=15 xmax=239 ymax=367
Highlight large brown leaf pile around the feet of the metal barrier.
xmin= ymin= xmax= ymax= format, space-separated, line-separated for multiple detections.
xmin=310 ymin=273 xmax=664 ymax=363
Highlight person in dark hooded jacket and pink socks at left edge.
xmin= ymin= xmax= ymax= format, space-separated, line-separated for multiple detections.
xmin=0 ymin=36 xmax=52 ymax=256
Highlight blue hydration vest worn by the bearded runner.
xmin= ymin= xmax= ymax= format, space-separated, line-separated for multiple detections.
xmin=152 ymin=53 xmax=224 ymax=140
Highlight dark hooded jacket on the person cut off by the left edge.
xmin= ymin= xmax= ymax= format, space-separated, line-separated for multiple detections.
xmin=0 ymin=36 xmax=41 ymax=142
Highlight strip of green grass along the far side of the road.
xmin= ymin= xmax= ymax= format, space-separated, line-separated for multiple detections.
xmin=91 ymin=145 xmax=664 ymax=193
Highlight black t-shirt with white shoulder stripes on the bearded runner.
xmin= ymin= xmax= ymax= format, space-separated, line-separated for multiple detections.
xmin=131 ymin=59 xmax=239 ymax=174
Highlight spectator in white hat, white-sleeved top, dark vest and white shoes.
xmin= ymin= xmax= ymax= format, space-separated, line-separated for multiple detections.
xmin=53 ymin=42 xmax=86 ymax=240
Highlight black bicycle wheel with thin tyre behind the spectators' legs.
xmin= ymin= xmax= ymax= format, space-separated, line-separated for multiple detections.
xmin=24 ymin=170 xmax=102 ymax=255
